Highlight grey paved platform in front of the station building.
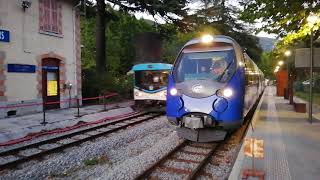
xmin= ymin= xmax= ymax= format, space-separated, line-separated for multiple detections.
xmin=0 ymin=101 xmax=134 ymax=143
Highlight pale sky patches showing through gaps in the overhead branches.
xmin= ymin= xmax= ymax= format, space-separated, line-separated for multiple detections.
xmin=134 ymin=0 xmax=277 ymax=39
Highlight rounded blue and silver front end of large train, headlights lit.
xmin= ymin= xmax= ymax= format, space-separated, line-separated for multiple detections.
xmin=166 ymin=36 xmax=245 ymax=142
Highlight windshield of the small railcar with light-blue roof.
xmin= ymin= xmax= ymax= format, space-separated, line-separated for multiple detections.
xmin=135 ymin=70 xmax=169 ymax=91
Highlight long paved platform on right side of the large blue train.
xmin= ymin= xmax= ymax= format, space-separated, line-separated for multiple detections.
xmin=229 ymin=86 xmax=320 ymax=180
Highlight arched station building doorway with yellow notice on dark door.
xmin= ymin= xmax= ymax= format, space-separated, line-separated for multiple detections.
xmin=42 ymin=58 xmax=60 ymax=110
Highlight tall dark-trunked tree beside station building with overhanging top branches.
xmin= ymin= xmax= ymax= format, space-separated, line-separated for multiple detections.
xmin=91 ymin=0 xmax=187 ymax=72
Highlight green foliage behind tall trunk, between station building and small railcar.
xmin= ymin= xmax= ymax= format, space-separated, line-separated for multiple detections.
xmin=81 ymin=9 xmax=155 ymax=97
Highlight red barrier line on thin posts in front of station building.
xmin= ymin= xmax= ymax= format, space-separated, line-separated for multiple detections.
xmin=0 ymin=93 xmax=118 ymax=125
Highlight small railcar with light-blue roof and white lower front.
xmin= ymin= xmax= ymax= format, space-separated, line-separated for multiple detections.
xmin=131 ymin=63 xmax=172 ymax=102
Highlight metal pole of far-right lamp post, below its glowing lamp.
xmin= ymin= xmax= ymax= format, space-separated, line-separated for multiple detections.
xmin=309 ymin=26 xmax=313 ymax=123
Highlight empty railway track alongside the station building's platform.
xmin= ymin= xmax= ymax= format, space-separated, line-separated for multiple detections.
xmin=0 ymin=112 xmax=162 ymax=171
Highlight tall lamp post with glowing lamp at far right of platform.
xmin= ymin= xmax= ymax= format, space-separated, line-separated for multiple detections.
xmin=307 ymin=14 xmax=319 ymax=123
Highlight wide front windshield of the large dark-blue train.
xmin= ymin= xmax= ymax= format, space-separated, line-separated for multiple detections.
xmin=174 ymin=49 xmax=235 ymax=83
